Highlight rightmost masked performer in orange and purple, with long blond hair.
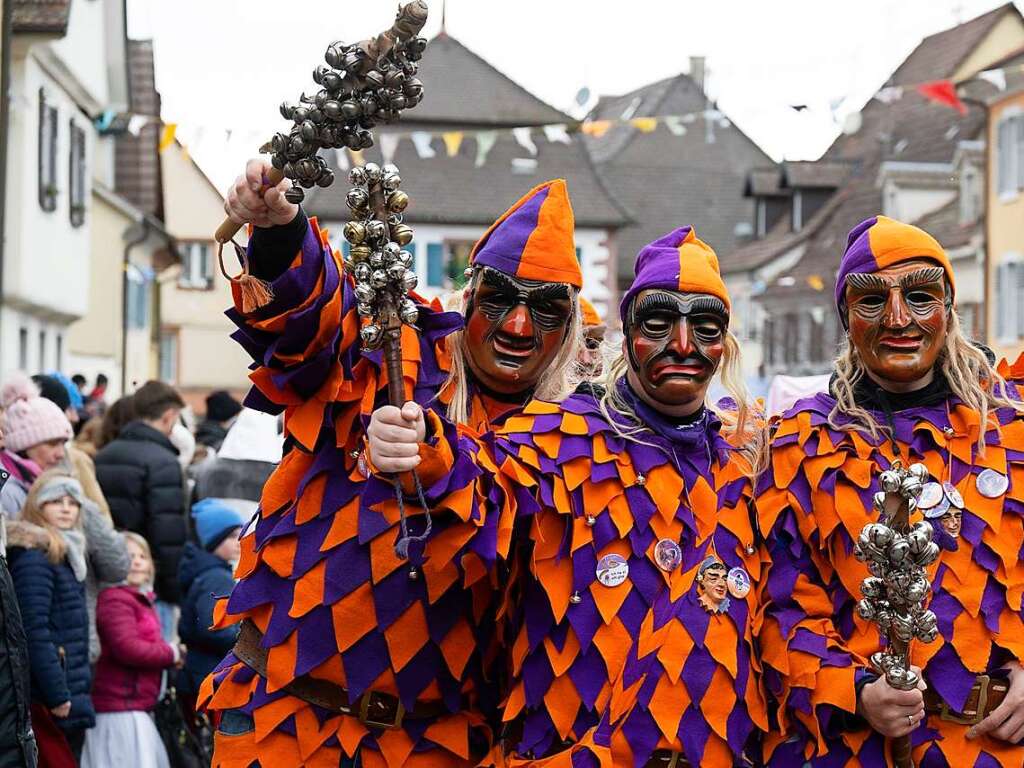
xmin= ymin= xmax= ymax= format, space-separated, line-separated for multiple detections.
xmin=757 ymin=216 xmax=1024 ymax=766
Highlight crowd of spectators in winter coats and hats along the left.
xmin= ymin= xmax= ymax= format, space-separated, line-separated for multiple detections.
xmin=0 ymin=373 xmax=283 ymax=768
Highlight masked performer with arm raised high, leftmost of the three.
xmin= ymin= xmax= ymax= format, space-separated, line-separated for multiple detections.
xmin=200 ymin=161 xmax=582 ymax=768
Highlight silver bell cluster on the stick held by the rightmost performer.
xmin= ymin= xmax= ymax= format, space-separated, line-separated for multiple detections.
xmin=853 ymin=464 xmax=939 ymax=690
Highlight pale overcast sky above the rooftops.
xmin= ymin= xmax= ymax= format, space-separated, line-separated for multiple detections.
xmin=128 ymin=0 xmax=1022 ymax=187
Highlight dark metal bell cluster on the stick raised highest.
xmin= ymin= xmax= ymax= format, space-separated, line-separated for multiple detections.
xmin=266 ymin=37 xmax=427 ymax=203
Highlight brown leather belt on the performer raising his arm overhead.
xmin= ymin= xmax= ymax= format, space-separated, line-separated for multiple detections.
xmin=234 ymin=618 xmax=451 ymax=729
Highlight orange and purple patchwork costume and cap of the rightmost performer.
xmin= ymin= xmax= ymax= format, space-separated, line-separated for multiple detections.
xmin=756 ymin=216 xmax=1024 ymax=766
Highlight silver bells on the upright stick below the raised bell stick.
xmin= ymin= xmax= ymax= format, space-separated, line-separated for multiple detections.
xmin=344 ymin=163 xmax=419 ymax=348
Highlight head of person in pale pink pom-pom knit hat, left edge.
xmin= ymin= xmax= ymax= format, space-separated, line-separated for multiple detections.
xmin=0 ymin=374 xmax=74 ymax=517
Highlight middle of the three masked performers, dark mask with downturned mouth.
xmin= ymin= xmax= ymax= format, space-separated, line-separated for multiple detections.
xmin=368 ymin=227 xmax=767 ymax=768
